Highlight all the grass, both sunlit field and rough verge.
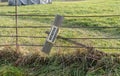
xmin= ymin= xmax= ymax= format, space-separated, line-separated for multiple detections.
xmin=0 ymin=0 xmax=120 ymax=76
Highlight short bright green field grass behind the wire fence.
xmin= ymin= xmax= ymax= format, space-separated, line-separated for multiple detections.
xmin=0 ymin=0 xmax=120 ymax=52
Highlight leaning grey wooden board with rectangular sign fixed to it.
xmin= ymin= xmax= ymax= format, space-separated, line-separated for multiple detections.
xmin=42 ymin=15 xmax=63 ymax=54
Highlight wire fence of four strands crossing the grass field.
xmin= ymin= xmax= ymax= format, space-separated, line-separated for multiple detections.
xmin=0 ymin=1 xmax=120 ymax=50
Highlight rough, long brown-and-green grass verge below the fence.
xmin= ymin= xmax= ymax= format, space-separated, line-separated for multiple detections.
xmin=0 ymin=47 xmax=120 ymax=76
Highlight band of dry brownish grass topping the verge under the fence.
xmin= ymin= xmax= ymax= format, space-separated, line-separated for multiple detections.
xmin=0 ymin=47 xmax=120 ymax=75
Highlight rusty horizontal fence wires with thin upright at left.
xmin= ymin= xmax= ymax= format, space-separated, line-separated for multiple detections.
xmin=0 ymin=4 xmax=120 ymax=51
